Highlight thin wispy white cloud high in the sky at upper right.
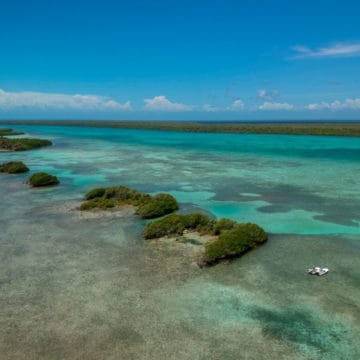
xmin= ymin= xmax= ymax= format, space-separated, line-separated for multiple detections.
xmin=292 ymin=43 xmax=360 ymax=58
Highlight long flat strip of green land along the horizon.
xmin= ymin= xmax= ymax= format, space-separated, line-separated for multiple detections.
xmin=0 ymin=120 xmax=360 ymax=137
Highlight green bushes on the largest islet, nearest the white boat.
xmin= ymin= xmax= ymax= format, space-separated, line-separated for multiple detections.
xmin=144 ymin=213 xmax=267 ymax=265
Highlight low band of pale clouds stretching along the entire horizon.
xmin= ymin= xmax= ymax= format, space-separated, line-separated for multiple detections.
xmin=0 ymin=89 xmax=360 ymax=115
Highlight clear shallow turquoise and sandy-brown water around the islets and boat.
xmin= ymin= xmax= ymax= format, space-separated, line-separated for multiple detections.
xmin=0 ymin=125 xmax=360 ymax=360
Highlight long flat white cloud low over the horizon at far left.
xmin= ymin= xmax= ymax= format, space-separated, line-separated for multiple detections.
xmin=0 ymin=89 xmax=131 ymax=111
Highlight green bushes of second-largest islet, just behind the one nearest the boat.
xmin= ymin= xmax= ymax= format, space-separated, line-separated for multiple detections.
xmin=80 ymin=186 xmax=179 ymax=219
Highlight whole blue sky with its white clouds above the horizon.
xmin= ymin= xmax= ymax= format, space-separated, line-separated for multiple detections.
xmin=0 ymin=0 xmax=360 ymax=120
